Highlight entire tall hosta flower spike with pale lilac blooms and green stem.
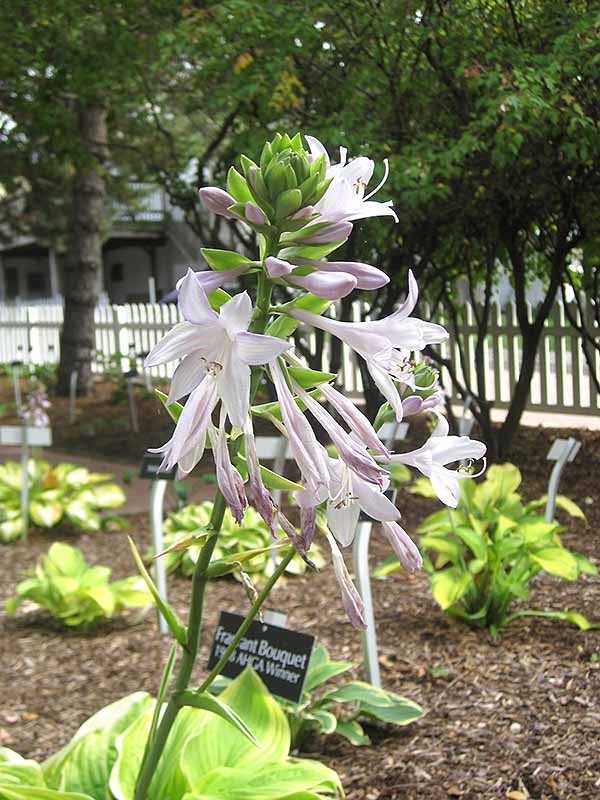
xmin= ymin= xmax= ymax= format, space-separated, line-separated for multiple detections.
xmin=129 ymin=134 xmax=485 ymax=800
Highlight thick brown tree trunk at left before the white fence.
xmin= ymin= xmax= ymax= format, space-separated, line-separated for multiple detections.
xmin=57 ymin=103 xmax=108 ymax=395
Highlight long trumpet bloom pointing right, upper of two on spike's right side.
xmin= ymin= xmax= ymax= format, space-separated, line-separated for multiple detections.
xmin=289 ymin=271 xmax=448 ymax=422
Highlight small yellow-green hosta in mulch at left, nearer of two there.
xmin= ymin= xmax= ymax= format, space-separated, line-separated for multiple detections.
xmin=6 ymin=542 xmax=152 ymax=628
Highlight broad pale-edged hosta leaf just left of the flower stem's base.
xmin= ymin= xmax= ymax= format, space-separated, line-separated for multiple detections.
xmin=42 ymin=692 xmax=153 ymax=800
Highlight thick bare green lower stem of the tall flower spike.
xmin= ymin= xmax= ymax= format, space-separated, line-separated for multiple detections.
xmin=134 ymin=491 xmax=225 ymax=800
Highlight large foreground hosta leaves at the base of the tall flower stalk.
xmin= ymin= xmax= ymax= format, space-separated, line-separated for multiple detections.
xmin=0 ymin=668 xmax=343 ymax=800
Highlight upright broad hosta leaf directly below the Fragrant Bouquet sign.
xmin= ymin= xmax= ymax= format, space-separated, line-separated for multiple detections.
xmin=182 ymin=668 xmax=290 ymax=791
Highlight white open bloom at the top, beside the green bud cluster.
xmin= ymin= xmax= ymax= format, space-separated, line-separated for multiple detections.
xmin=306 ymin=136 xmax=398 ymax=222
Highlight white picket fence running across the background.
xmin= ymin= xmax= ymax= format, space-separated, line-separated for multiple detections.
xmin=0 ymin=296 xmax=600 ymax=415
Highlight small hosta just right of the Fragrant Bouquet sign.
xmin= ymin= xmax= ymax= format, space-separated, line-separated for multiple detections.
xmin=213 ymin=644 xmax=423 ymax=750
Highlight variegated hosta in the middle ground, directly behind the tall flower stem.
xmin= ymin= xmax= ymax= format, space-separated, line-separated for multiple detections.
xmin=155 ymin=501 xmax=325 ymax=583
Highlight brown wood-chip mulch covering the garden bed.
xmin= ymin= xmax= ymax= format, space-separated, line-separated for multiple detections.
xmin=0 ymin=429 xmax=600 ymax=800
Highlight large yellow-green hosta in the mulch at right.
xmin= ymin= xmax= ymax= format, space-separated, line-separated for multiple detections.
xmin=376 ymin=464 xmax=597 ymax=634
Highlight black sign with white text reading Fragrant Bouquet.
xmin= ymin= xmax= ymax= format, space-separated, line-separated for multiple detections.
xmin=208 ymin=611 xmax=315 ymax=703
